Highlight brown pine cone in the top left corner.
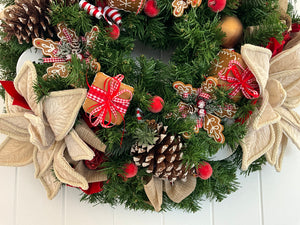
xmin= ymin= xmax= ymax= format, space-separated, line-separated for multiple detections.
xmin=1 ymin=0 xmax=54 ymax=44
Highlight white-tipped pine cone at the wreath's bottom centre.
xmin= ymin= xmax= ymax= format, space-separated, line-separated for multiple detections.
xmin=131 ymin=121 xmax=188 ymax=182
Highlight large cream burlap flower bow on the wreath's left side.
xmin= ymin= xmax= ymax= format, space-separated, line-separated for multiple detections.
xmin=0 ymin=62 xmax=106 ymax=199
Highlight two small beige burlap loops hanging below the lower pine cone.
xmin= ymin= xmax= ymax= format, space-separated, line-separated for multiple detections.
xmin=144 ymin=175 xmax=197 ymax=212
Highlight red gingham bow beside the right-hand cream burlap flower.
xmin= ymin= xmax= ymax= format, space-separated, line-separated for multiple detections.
xmin=218 ymin=60 xmax=259 ymax=99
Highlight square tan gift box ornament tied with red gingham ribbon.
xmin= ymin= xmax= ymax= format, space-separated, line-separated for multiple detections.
xmin=83 ymin=72 xmax=134 ymax=128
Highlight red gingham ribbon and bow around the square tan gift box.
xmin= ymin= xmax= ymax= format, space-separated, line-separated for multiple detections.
xmin=87 ymin=74 xmax=132 ymax=128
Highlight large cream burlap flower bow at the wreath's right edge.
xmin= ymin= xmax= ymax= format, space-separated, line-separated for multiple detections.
xmin=241 ymin=34 xmax=300 ymax=171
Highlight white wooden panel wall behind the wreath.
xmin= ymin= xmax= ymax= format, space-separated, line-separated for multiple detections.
xmin=0 ymin=2 xmax=300 ymax=225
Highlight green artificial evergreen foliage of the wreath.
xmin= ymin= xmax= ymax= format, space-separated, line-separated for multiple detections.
xmin=0 ymin=0 xmax=299 ymax=212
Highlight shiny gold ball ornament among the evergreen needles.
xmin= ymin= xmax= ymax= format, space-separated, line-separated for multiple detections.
xmin=221 ymin=16 xmax=243 ymax=48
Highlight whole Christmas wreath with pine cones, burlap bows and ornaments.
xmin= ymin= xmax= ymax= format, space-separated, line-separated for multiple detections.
xmin=0 ymin=0 xmax=300 ymax=211
